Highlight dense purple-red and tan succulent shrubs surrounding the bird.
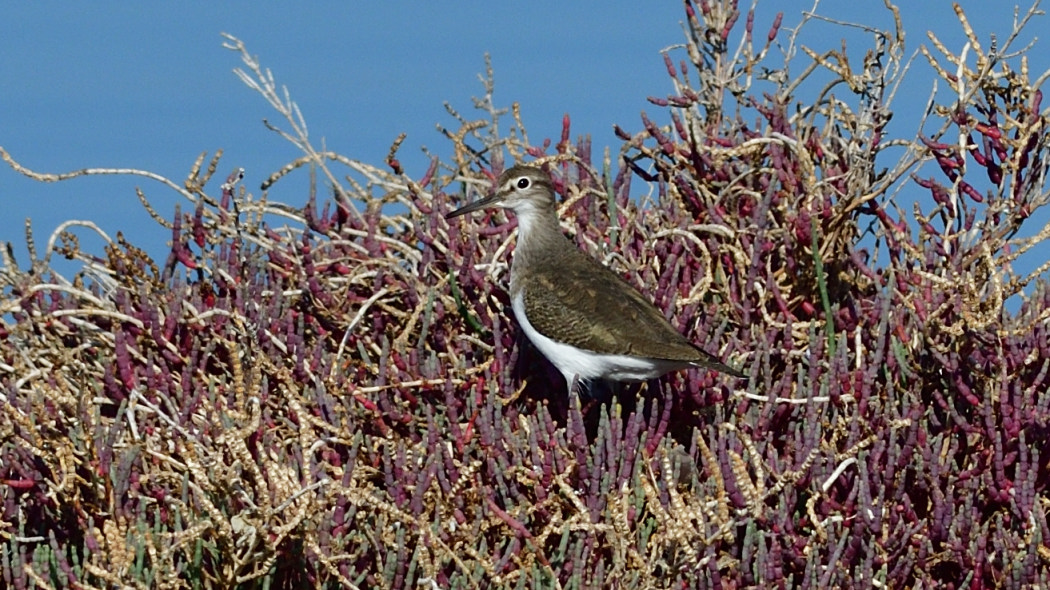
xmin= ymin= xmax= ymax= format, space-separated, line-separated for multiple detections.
xmin=0 ymin=1 xmax=1050 ymax=588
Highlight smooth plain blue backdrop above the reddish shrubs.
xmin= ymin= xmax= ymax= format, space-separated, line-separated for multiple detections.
xmin=0 ymin=0 xmax=1050 ymax=291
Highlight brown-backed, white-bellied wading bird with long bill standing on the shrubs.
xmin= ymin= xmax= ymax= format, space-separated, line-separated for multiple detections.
xmin=445 ymin=165 xmax=746 ymax=395
